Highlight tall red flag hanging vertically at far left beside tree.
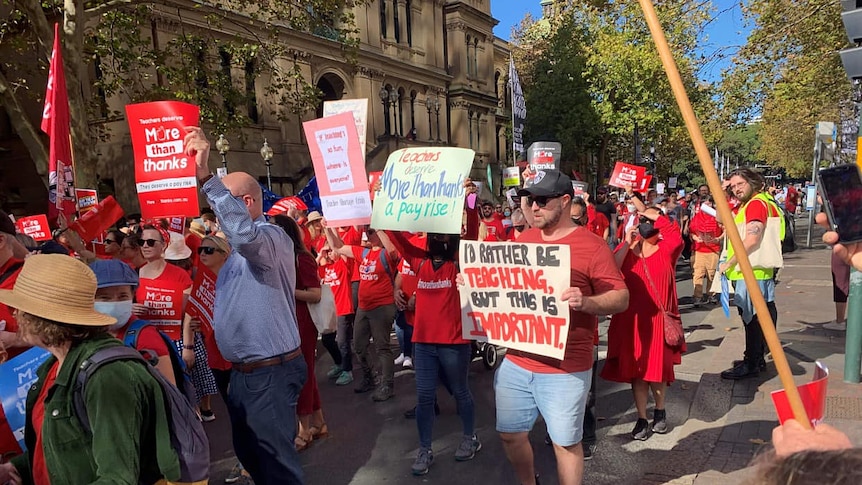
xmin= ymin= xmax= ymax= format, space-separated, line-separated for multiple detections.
xmin=42 ymin=23 xmax=77 ymax=221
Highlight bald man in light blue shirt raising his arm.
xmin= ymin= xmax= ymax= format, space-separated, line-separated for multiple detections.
xmin=185 ymin=127 xmax=306 ymax=485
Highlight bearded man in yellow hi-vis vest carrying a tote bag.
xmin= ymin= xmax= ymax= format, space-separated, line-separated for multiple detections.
xmin=718 ymin=167 xmax=784 ymax=380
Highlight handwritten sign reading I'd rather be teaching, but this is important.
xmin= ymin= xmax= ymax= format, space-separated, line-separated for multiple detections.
xmin=460 ymin=241 xmax=571 ymax=359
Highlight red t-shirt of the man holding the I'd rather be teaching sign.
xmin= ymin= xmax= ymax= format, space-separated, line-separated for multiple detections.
xmin=506 ymin=228 xmax=626 ymax=374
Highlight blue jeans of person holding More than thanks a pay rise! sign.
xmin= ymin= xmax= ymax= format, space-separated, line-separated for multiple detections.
xmin=413 ymin=343 xmax=475 ymax=449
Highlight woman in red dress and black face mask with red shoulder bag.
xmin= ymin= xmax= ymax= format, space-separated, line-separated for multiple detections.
xmin=601 ymin=189 xmax=685 ymax=440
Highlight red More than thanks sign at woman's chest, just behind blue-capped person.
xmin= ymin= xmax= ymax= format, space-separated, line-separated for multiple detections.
xmin=137 ymin=278 xmax=185 ymax=340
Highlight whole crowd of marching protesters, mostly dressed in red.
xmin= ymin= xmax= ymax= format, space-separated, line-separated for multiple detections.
xmin=0 ymin=124 xmax=862 ymax=484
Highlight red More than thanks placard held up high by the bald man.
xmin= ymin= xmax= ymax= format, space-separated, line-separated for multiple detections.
xmin=126 ymin=101 xmax=200 ymax=219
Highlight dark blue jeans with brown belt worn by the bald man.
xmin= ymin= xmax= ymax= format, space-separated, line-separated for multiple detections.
xmin=227 ymin=355 xmax=307 ymax=485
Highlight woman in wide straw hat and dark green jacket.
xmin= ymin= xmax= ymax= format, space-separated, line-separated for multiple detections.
xmin=0 ymin=254 xmax=180 ymax=485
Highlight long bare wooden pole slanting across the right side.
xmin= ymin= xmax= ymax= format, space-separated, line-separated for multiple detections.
xmin=638 ymin=0 xmax=811 ymax=429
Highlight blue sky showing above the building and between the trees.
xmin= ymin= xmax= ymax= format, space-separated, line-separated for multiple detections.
xmin=491 ymin=0 xmax=750 ymax=81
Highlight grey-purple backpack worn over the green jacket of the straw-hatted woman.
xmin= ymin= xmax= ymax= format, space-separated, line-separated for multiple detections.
xmin=72 ymin=345 xmax=210 ymax=482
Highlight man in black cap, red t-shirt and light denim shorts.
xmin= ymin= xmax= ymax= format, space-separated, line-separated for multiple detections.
xmin=494 ymin=170 xmax=629 ymax=485
